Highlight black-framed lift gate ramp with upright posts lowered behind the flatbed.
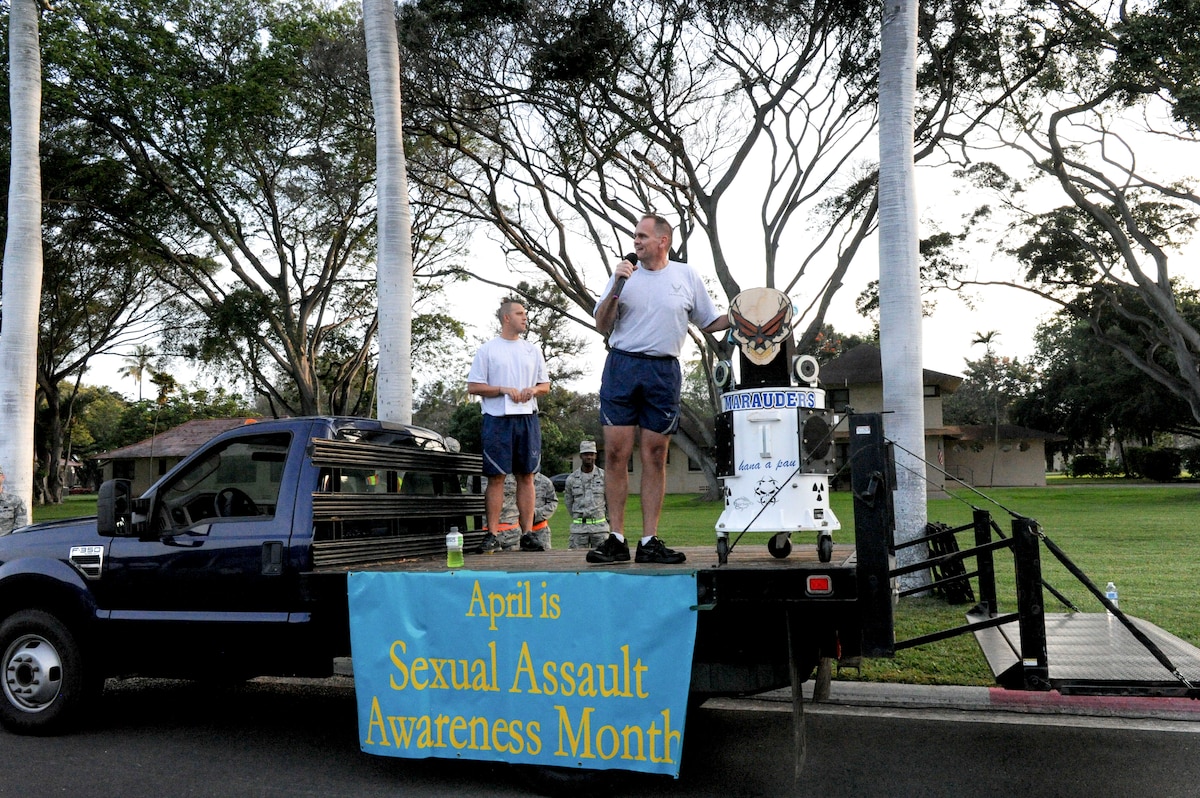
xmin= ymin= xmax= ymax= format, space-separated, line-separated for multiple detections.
xmin=851 ymin=414 xmax=1200 ymax=698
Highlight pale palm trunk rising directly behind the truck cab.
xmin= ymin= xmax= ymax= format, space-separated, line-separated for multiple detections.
xmin=362 ymin=0 xmax=413 ymax=424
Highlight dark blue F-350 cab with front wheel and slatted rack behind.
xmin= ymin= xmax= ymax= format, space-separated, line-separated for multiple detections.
xmin=0 ymin=418 xmax=484 ymax=733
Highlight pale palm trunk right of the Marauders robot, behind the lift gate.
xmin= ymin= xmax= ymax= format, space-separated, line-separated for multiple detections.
xmin=880 ymin=0 xmax=929 ymax=588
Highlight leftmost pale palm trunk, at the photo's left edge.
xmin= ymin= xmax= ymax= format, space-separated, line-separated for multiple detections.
xmin=0 ymin=0 xmax=42 ymax=506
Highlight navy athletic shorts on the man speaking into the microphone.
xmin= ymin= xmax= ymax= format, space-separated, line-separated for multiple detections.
xmin=600 ymin=349 xmax=683 ymax=436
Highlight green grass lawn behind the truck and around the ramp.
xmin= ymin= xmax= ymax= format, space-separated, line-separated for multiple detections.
xmin=34 ymin=480 xmax=1200 ymax=685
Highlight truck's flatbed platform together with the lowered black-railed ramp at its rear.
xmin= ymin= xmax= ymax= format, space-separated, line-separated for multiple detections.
xmin=322 ymin=414 xmax=1200 ymax=778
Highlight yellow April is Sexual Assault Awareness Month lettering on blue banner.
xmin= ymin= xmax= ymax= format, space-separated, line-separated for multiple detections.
xmin=362 ymin=578 xmax=688 ymax=764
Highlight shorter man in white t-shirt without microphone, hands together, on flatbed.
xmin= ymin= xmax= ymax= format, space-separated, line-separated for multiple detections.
xmin=467 ymin=299 xmax=550 ymax=552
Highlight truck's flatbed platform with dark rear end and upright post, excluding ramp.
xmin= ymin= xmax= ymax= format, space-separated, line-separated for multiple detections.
xmin=328 ymin=416 xmax=895 ymax=776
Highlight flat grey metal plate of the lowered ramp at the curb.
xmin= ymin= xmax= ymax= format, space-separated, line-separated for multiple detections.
xmin=974 ymin=612 xmax=1200 ymax=696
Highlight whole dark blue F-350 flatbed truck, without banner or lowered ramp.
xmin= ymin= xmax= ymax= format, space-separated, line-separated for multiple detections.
xmin=0 ymin=418 xmax=862 ymax=734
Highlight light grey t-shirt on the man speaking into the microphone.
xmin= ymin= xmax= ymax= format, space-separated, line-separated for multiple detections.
xmin=596 ymin=260 xmax=721 ymax=358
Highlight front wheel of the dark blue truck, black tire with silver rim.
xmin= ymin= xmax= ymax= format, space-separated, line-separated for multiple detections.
xmin=0 ymin=610 xmax=94 ymax=734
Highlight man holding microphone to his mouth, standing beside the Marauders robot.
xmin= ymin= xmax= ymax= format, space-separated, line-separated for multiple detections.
xmin=587 ymin=214 xmax=730 ymax=564
